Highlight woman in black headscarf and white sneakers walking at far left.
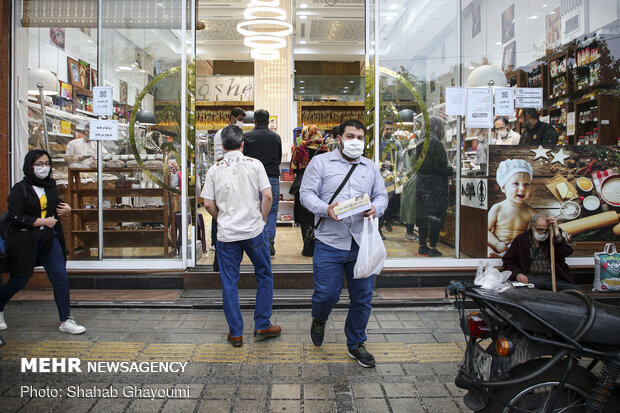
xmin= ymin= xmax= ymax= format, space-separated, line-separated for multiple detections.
xmin=0 ymin=149 xmax=86 ymax=334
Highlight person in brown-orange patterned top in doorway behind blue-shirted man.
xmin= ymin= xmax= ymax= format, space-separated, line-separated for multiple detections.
xmin=289 ymin=125 xmax=329 ymax=257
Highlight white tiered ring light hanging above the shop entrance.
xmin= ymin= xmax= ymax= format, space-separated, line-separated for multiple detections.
xmin=237 ymin=0 xmax=293 ymax=60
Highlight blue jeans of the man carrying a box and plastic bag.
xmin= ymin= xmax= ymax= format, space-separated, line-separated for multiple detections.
xmin=312 ymin=239 xmax=375 ymax=349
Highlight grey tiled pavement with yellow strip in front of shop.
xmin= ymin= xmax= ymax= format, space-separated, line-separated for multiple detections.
xmin=0 ymin=301 xmax=467 ymax=413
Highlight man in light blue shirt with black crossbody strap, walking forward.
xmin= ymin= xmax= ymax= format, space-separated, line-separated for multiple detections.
xmin=300 ymin=120 xmax=388 ymax=367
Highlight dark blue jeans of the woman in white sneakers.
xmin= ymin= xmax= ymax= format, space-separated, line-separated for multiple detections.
xmin=0 ymin=237 xmax=71 ymax=322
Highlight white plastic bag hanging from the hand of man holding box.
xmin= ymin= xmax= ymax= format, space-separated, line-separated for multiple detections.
xmin=353 ymin=217 xmax=387 ymax=278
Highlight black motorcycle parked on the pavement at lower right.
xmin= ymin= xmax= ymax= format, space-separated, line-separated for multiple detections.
xmin=446 ymin=281 xmax=620 ymax=413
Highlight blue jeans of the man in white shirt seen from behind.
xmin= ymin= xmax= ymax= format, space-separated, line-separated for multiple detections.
xmin=216 ymin=231 xmax=273 ymax=337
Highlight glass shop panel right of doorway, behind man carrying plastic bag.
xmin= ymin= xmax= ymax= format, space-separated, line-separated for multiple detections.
xmin=377 ymin=1 xmax=459 ymax=259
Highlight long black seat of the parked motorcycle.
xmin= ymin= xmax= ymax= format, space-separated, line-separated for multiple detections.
xmin=478 ymin=288 xmax=620 ymax=346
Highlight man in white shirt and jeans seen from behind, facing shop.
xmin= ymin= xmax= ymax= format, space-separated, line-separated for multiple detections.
xmin=201 ymin=125 xmax=282 ymax=347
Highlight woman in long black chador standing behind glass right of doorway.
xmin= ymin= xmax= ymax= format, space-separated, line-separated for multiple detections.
xmin=416 ymin=116 xmax=452 ymax=257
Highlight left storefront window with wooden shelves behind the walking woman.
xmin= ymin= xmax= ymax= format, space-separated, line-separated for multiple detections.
xmin=13 ymin=0 xmax=195 ymax=260
